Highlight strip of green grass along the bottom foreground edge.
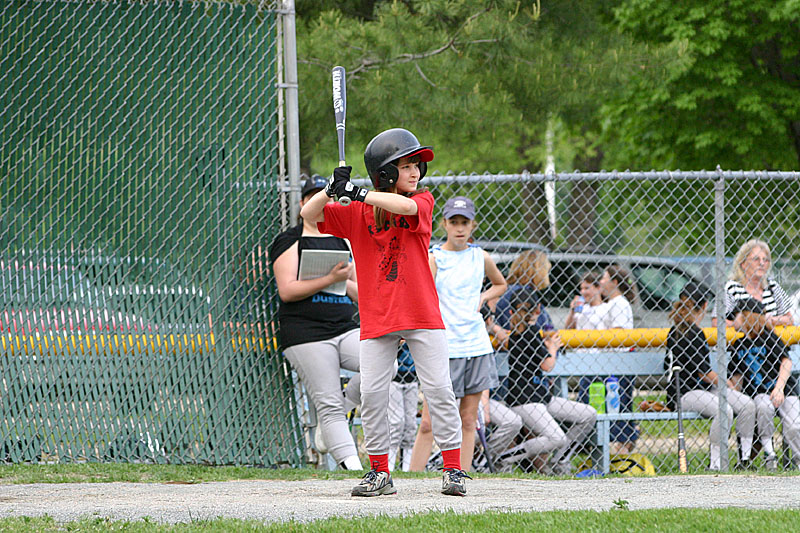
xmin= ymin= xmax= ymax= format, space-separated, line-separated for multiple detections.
xmin=0 ymin=504 xmax=800 ymax=533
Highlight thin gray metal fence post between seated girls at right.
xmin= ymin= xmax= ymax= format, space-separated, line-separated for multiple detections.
xmin=714 ymin=165 xmax=731 ymax=472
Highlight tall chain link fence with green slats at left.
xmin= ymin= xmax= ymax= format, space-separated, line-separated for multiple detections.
xmin=0 ymin=0 xmax=304 ymax=465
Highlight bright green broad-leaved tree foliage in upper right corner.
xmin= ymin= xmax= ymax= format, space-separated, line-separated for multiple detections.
xmin=603 ymin=0 xmax=800 ymax=170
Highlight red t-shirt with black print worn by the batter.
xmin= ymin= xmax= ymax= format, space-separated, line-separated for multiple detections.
xmin=317 ymin=191 xmax=444 ymax=339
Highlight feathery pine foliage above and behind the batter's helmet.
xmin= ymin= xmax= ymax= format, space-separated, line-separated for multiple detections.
xmin=297 ymin=0 xmax=641 ymax=173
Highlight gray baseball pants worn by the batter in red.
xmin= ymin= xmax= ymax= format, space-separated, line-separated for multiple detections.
xmin=360 ymin=329 xmax=461 ymax=455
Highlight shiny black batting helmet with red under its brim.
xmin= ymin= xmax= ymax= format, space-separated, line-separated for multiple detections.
xmin=364 ymin=128 xmax=433 ymax=190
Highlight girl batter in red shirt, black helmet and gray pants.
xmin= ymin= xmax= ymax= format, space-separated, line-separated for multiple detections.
xmin=301 ymin=128 xmax=466 ymax=496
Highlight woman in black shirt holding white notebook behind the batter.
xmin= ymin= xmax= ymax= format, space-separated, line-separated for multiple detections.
xmin=269 ymin=176 xmax=362 ymax=470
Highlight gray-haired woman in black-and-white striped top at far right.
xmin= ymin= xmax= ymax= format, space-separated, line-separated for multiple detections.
xmin=712 ymin=239 xmax=792 ymax=327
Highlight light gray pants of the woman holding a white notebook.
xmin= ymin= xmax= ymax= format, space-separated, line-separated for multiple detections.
xmin=284 ymin=329 xmax=361 ymax=463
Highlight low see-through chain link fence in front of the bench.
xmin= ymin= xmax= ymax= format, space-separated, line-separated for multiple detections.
xmin=340 ymin=170 xmax=800 ymax=473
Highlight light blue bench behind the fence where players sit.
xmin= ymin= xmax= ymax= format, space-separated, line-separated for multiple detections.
xmin=546 ymin=345 xmax=800 ymax=474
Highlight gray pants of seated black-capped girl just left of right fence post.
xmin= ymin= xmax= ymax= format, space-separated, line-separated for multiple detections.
xmin=681 ymin=389 xmax=756 ymax=448
